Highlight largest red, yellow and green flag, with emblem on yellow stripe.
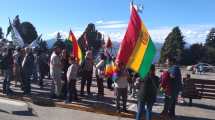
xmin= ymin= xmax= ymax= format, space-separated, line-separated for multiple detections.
xmin=116 ymin=6 xmax=156 ymax=78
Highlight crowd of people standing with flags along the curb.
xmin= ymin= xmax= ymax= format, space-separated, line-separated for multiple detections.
xmin=1 ymin=41 xmax=182 ymax=120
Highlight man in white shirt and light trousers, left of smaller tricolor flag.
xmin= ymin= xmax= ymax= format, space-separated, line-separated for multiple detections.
xmin=50 ymin=45 xmax=63 ymax=98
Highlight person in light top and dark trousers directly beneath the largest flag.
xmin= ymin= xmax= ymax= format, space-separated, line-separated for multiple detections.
xmin=114 ymin=63 xmax=129 ymax=112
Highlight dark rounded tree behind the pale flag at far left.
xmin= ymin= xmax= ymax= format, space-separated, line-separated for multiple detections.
xmin=20 ymin=22 xmax=38 ymax=44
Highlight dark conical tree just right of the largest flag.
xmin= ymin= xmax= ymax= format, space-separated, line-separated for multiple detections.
xmin=159 ymin=27 xmax=185 ymax=63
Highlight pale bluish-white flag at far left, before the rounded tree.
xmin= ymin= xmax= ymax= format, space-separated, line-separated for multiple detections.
xmin=9 ymin=19 xmax=24 ymax=47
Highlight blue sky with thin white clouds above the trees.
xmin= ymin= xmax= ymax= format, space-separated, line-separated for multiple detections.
xmin=0 ymin=0 xmax=215 ymax=43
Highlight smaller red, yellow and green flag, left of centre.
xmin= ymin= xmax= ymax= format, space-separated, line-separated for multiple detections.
xmin=68 ymin=30 xmax=83 ymax=64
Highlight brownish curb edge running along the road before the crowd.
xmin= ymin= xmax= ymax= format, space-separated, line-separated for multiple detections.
xmin=0 ymin=90 xmax=159 ymax=120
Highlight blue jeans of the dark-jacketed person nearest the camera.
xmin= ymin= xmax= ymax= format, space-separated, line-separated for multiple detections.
xmin=136 ymin=101 xmax=153 ymax=120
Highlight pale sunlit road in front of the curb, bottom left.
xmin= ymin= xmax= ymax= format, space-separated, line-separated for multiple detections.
xmin=0 ymin=98 xmax=132 ymax=120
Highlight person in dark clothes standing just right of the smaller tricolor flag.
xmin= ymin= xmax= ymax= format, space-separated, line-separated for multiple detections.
xmin=81 ymin=50 xmax=93 ymax=95
